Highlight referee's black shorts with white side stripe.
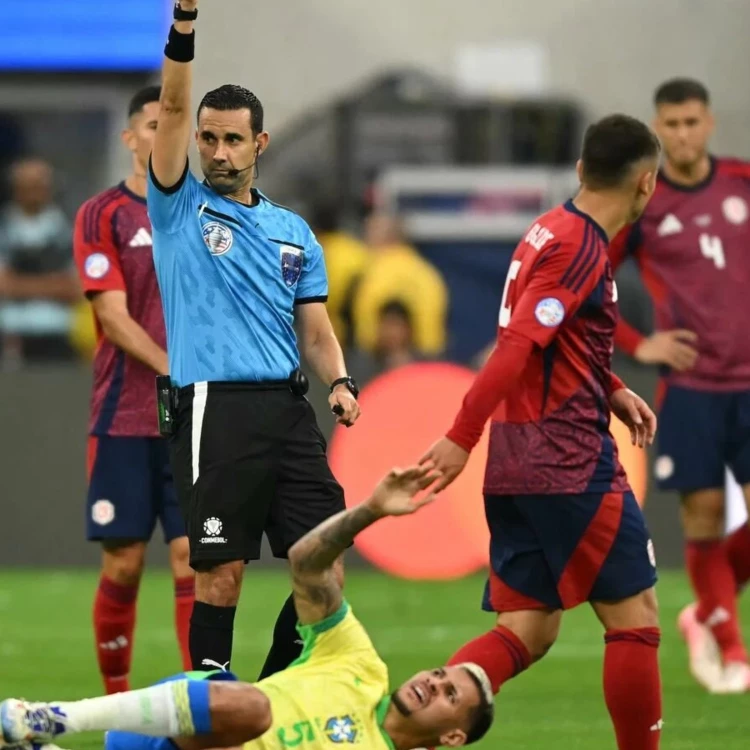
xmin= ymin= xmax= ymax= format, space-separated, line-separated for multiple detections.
xmin=170 ymin=383 xmax=345 ymax=567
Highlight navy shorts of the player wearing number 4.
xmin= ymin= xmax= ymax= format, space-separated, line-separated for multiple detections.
xmin=654 ymin=386 xmax=750 ymax=492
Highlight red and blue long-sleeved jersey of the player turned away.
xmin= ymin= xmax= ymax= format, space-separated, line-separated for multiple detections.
xmin=448 ymin=201 xmax=629 ymax=495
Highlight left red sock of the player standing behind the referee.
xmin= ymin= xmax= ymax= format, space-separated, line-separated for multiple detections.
xmin=94 ymin=576 xmax=138 ymax=695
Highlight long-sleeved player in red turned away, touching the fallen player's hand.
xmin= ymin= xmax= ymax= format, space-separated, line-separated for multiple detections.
xmin=422 ymin=115 xmax=662 ymax=750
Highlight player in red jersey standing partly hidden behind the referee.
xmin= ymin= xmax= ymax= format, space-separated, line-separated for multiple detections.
xmin=74 ymin=86 xmax=194 ymax=693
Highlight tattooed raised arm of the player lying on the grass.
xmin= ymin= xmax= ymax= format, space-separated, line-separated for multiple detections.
xmin=289 ymin=463 xmax=440 ymax=624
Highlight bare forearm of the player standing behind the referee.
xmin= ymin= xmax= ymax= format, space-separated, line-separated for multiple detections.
xmin=91 ymin=290 xmax=169 ymax=375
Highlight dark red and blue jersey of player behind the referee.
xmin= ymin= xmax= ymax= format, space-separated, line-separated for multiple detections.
xmin=74 ymin=183 xmax=166 ymax=437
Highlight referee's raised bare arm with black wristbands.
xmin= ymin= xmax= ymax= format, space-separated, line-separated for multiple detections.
xmin=151 ymin=0 xmax=198 ymax=188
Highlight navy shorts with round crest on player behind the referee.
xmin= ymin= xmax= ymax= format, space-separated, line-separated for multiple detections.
xmin=86 ymin=436 xmax=185 ymax=543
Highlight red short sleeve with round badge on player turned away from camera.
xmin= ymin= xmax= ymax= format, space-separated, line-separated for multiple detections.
xmin=507 ymin=243 xmax=602 ymax=349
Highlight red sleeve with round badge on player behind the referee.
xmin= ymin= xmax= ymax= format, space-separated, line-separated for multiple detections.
xmin=73 ymin=198 xmax=125 ymax=294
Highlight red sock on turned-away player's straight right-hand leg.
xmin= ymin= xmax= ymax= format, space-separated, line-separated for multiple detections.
xmin=604 ymin=628 xmax=662 ymax=750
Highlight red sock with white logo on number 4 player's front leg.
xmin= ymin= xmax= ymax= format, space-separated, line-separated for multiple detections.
xmin=686 ymin=539 xmax=747 ymax=663
